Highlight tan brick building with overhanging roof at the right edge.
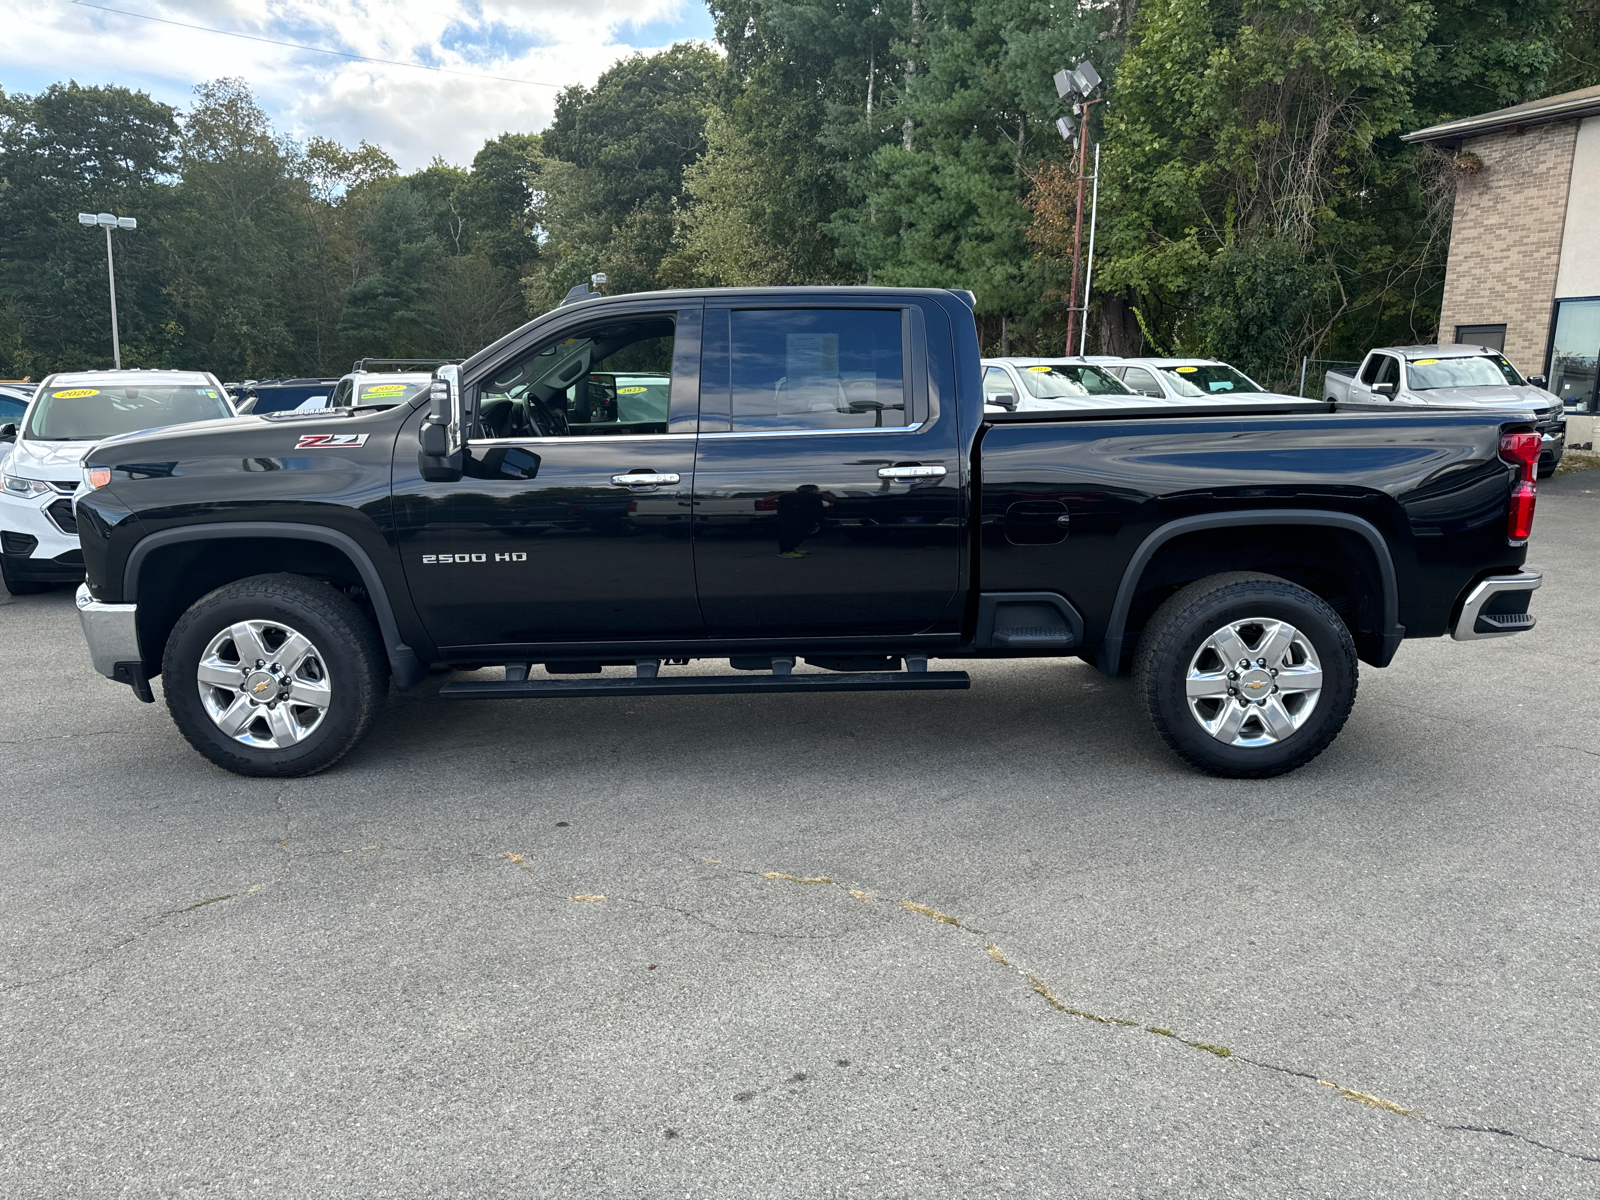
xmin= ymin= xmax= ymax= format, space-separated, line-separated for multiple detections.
xmin=1405 ymin=86 xmax=1600 ymax=443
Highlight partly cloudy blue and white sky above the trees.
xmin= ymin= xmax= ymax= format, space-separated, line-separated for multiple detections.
xmin=0 ymin=0 xmax=712 ymax=170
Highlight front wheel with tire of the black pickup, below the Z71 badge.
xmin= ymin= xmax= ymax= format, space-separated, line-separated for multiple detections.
xmin=162 ymin=574 xmax=389 ymax=776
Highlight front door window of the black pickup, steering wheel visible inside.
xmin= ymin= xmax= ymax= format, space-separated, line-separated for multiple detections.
xmin=474 ymin=315 xmax=674 ymax=440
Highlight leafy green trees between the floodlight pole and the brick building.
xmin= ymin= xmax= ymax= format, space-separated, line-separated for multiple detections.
xmin=1098 ymin=0 xmax=1562 ymax=381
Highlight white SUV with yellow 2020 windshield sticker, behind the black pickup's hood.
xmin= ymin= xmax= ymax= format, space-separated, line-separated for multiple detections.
xmin=0 ymin=371 xmax=234 ymax=595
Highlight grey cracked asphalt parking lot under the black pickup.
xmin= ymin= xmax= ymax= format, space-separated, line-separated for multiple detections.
xmin=0 ymin=472 xmax=1600 ymax=1200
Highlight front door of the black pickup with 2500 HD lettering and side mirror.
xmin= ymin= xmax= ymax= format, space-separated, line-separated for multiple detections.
xmin=394 ymin=307 xmax=704 ymax=648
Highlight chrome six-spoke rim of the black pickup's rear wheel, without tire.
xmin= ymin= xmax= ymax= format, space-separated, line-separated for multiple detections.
xmin=1184 ymin=616 xmax=1322 ymax=747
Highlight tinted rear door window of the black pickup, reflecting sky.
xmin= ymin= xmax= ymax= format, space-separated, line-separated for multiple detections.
xmin=731 ymin=309 xmax=912 ymax=430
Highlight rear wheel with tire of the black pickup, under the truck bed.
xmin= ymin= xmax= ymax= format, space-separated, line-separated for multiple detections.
xmin=1133 ymin=571 xmax=1357 ymax=779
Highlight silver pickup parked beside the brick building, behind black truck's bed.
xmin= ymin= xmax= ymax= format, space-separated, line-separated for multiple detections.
xmin=1323 ymin=346 xmax=1566 ymax=475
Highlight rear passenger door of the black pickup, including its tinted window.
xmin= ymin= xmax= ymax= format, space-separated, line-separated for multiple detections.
xmin=694 ymin=301 xmax=963 ymax=638
